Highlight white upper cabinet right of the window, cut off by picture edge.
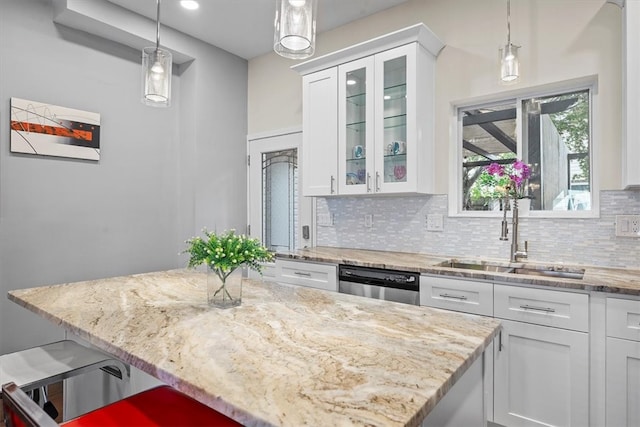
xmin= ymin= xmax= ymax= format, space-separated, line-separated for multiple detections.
xmin=622 ymin=0 xmax=640 ymax=188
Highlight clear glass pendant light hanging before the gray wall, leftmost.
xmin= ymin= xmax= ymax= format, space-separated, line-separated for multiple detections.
xmin=142 ymin=0 xmax=171 ymax=107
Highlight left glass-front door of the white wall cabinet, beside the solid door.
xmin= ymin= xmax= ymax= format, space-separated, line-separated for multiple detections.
xmin=338 ymin=57 xmax=375 ymax=194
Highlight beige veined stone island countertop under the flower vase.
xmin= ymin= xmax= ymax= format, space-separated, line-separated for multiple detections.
xmin=8 ymin=270 xmax=500 ymax=426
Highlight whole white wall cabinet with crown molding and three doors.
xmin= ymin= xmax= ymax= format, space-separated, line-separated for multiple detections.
xmin=292 ymin=24 xmax=444 ymax=196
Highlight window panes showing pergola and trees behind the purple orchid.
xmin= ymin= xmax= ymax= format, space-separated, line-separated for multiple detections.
xmin=458 ymin=89 xmax=592 ymax=211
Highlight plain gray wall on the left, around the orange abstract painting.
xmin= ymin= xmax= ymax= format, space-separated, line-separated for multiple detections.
xmin=0 ymin=0 xmax=247 ymax=354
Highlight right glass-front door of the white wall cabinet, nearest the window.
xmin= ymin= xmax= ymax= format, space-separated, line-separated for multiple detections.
xmin=374 ymin=43 xmax=424 ymax=192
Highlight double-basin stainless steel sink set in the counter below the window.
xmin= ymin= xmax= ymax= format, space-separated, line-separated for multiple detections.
xmin=438 ymin=260 xmax=584 ymax=280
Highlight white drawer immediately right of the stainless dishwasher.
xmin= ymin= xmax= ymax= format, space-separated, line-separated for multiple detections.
xmin=420 ymin=275 xmax=493 ymax=316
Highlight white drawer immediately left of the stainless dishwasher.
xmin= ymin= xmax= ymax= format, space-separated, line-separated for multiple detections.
xmin=276 ymin=259 xmax=338 ymax=292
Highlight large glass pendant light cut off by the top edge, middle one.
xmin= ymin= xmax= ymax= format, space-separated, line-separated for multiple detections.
xmin=273 ymin=0 xmax=317 ymax=59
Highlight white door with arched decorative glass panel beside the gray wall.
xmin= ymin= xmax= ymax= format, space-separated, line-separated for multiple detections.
xmin=248 ymin=132 xmax=313 ymax=258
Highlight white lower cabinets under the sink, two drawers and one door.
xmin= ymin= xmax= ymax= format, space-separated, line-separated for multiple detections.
xmin=420 ymin=275 xmax=592 ymax=427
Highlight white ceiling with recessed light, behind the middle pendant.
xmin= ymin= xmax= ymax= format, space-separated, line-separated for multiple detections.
xmin=109 ymin=0 xmax=407 ymax=59
